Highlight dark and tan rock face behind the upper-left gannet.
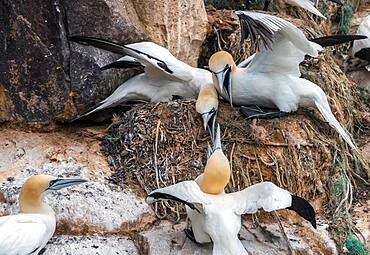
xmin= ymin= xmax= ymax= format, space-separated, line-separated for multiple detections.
xmin=0 ymin=0 xmax=207 ymax=122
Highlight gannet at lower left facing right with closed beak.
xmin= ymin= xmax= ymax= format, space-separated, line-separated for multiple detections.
xmin=0 ymin=175 xmax=86 ymax=255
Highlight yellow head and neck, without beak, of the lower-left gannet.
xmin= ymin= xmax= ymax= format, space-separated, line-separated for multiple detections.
xmin=19 ymin=175 xmax=54 ymax=214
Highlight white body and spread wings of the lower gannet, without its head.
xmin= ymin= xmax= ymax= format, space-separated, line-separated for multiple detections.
xmin=147 ymin=181 xmax=316 ymax=255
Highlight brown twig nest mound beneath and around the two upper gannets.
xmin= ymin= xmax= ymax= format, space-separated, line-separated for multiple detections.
xmin=103 ymin=8 xmax=370 ymax=252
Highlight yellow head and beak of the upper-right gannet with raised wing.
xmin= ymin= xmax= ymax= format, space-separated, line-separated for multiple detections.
xmin=208 ymin=51 xmax=236 ymax=105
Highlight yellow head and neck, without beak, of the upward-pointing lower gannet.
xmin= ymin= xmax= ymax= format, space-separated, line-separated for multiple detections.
xmin=198 ymin=149 xmax=230 ymax=195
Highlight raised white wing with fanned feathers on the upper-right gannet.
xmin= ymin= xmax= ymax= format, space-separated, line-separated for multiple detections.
xmin=235 ymin=11 xmax=322 ymax=77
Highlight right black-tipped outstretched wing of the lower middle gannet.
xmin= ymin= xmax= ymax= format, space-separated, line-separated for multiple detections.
xmin=230 ymin=182 xmax=316 ymax=228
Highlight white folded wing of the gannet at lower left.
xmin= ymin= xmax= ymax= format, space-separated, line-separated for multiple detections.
xmin=0 ymin=214 xmax=46 ymax=255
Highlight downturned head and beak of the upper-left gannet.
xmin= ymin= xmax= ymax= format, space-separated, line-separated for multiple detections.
xmin=195 ymin=84 xmax=218 ymax=141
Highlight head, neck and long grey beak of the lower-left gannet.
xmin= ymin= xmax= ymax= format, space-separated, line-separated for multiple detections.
xmin=19 ymin=175 xmax=87 ymax=213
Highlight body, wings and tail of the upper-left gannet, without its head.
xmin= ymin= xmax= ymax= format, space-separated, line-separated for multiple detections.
xmin=69 ymin=36 xmax=212 ymax=118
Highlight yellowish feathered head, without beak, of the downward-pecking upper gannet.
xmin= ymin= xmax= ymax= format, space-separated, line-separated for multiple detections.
xmin=195 ymin=84 xmax=218 ymax=114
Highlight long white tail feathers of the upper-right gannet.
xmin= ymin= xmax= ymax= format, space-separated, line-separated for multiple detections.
xmin=314 ymin=91 xmax=358 ymax=152
